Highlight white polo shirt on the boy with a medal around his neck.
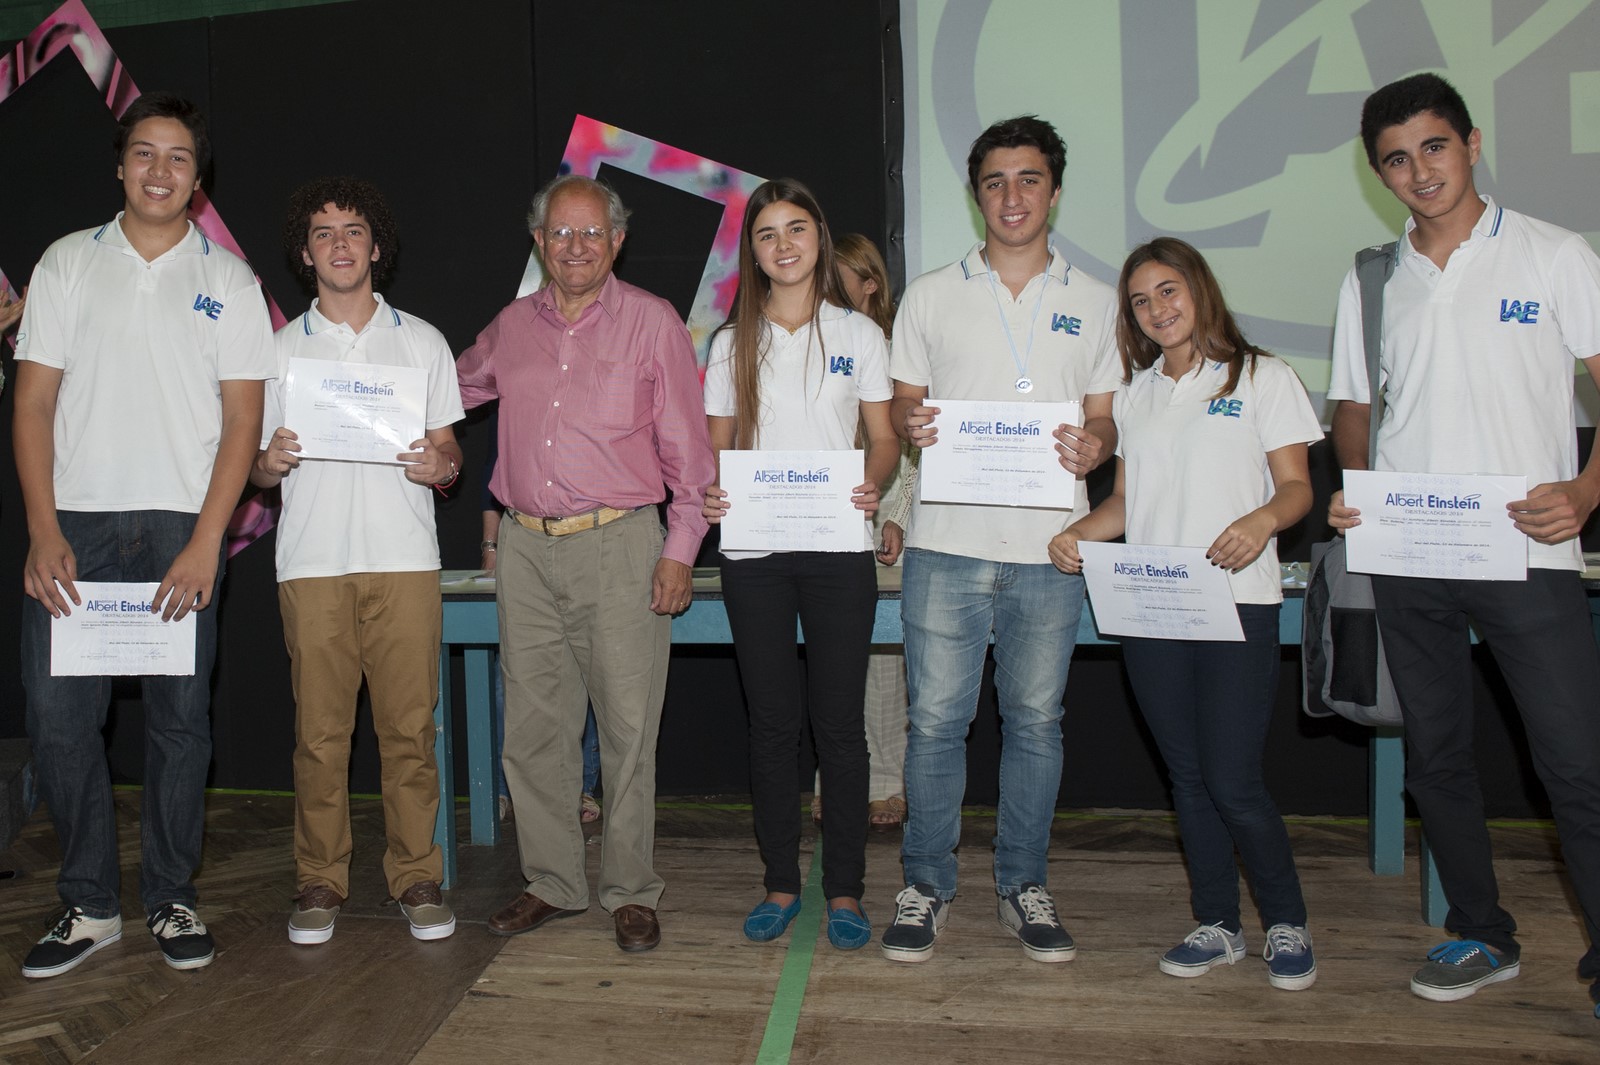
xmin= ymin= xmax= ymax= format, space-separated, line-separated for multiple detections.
xmin=890 ymin=243 xmax=1122 ymax=564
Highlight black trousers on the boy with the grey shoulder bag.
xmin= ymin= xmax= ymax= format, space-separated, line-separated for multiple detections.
xmin=1373 ymin=569 xmax=1600 ymax=948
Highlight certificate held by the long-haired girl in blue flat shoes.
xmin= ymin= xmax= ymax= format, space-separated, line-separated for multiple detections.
xmin=722 ymin=451 xmax=872 ymax=552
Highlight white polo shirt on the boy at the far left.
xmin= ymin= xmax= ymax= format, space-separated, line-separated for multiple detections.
xmin=16 ymin=214 xmax=275 ymax=513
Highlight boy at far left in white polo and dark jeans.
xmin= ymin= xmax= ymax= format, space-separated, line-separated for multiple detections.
xmin=13 ymin=93 xmax=272 ymax=977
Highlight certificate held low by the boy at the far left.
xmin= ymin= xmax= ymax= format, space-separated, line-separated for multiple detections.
xmin=50 ymin=580 xmax=195 ymax=676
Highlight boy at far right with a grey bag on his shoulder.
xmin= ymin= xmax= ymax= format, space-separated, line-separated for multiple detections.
xmin=1328 ymin=74 xmax=1600 ymax=1001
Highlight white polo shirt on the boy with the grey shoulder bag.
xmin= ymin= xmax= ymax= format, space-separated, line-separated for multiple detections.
xmin=1328 ymin=197 xmax=1600 ymax=569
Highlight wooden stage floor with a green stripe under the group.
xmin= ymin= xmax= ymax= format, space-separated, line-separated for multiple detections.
xmin=0 ymin=792 xmax=1600 ymax=1065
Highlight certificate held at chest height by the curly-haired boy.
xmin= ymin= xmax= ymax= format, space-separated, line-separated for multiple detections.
xmin=283 ymin=358 xmax=427 ymax=465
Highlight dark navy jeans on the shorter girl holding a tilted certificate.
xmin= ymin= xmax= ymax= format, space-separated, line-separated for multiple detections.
xmin=1122 ymin=603 xmax=1306 ymax=931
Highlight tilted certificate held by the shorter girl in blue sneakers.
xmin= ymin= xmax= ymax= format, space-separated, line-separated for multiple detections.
xmin=1078 ymin=540 xmax=1245 ymax=643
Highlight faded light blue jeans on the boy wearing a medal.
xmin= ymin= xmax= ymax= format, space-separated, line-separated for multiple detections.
xmin=901 ymin=548 xmax=1083 ymax=899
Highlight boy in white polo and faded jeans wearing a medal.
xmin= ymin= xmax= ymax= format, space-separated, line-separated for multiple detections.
xmin=882 ymin=115 xmax=1122 ymax=961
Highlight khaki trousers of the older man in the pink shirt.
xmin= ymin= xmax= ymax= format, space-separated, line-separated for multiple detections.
xmin=496 ymin=507 xmax=672 ymax=910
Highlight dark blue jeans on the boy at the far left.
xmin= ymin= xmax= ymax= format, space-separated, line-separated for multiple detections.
xmin=21 ymin=510 xmax=224 ymax=918
